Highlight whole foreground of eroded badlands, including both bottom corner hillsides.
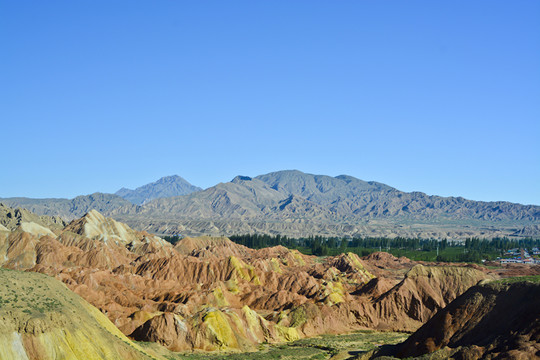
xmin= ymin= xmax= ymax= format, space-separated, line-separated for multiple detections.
xmin=0 ymin=202 xmax=540 ymax=360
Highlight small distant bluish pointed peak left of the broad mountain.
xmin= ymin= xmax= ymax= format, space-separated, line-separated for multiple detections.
xmin=115 ymin=175 xmax=202 ymax=205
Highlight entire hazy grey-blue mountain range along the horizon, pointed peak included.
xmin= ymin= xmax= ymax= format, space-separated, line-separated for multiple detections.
xmin=0 ymin=170 xmax=540 ymax=238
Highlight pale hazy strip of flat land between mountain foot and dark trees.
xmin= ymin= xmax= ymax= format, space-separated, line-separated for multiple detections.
xmin=113 ymin=215 xmax=536 ymax=239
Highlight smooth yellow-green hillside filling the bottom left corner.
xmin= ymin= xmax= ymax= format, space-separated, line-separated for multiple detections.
xmin=0 ymin=268 xmax=154 ymax=360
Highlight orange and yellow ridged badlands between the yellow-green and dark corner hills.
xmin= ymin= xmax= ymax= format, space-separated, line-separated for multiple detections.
xmin=0 ymin=206 xmax=540 ymax=358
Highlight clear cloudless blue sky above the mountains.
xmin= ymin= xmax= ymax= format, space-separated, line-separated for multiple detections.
xmin=0 ymin=0 xmax=540 ymax=204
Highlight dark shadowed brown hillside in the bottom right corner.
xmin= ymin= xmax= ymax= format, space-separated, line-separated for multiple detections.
xmin=371 ymin=277 xmax=540 ymax=359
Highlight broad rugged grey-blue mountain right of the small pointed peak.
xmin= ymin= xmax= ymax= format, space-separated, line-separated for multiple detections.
xmin=120 ymin=171 xmax=540 ymax=221
